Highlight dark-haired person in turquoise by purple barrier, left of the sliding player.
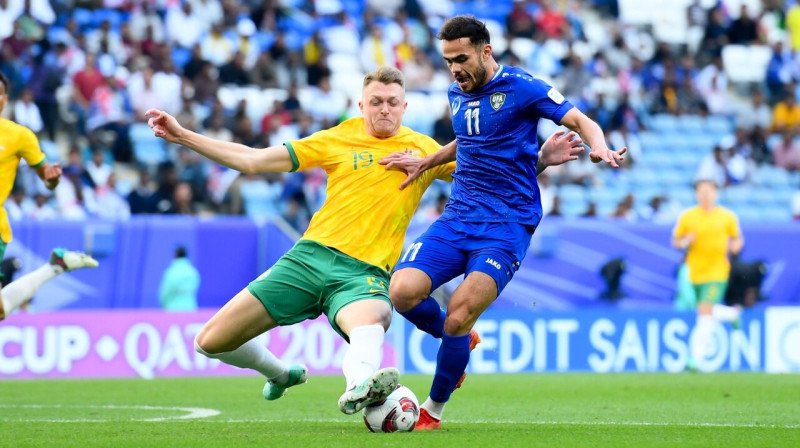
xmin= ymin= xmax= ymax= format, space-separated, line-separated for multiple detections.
xmin=158 ymin=246 xmax=200 ymax=312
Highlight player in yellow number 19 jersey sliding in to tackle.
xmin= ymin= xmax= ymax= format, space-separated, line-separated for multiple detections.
xmin=146 ymin=67 xmax=581 ymax=414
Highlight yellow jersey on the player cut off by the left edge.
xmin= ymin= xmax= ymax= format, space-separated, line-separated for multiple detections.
xmin=0 ymin=118 xmax=45 ymax=243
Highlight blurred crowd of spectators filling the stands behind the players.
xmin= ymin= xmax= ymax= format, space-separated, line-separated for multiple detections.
xmin=0 ymin=0 xmax=800 ymax=231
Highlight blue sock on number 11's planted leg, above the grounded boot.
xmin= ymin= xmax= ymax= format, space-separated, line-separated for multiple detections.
xmin=430 ymin=334 xmax=469 ymax=403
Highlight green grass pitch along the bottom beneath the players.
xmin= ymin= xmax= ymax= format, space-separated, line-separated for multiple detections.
xmin=0 ymin=373 xmax=800 ymax=448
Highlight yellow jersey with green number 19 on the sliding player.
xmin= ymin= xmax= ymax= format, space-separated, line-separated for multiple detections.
xmin=286 ymin=117 xmax=455 ymax=271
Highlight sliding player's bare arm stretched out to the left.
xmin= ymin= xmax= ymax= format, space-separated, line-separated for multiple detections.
xmin=145 ymin=109 xmax=292 ymax=174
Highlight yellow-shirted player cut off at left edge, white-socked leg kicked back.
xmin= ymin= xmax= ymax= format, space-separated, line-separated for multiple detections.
xmin=0 ymin=73 xmax=97 ymax=320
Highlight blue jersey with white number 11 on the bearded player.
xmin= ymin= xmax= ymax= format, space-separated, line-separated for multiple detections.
xmin=442 ymin=65 xmax=572 ymax=226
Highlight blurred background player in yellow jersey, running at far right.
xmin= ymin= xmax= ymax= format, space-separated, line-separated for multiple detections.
xmin=672 ymin=180 xmax=744 ymax=370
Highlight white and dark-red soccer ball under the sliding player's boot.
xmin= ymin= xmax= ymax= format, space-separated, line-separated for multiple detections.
xmin=364 ymin=384 xmax=419 ymax=432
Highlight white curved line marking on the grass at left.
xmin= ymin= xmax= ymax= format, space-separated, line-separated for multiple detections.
xmin=0 ymin=404 xmax=220 ymax=423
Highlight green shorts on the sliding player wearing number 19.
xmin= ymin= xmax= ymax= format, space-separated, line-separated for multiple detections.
xmin=247 ymin=240 xmax=392 ymax=342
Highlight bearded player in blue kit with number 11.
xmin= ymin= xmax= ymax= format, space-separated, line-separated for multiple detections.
xmin=381 ymin=16 xmax=624 ymax=430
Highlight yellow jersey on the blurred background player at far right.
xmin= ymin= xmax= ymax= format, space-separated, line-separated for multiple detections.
xmin=673 ymin=206 xmax=742 ymax=284
